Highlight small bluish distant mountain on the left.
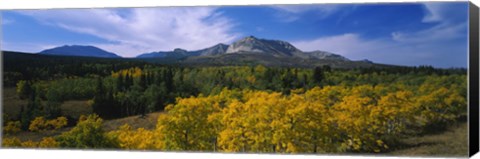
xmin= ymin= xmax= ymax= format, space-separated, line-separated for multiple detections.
xmin=39 ymin=45 xmax=121 ymax=58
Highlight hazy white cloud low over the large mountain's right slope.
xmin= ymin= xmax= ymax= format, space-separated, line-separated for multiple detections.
xmin=292 ymin=33 xmax=467 ymax=67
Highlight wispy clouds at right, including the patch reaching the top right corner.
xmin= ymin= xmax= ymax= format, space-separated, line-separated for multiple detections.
xmin=293 ymin=3 xmax=467 ymax=67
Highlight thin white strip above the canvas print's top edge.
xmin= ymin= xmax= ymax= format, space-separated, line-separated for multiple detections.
xmin=0 ymin=0 xmax=472 ymax=9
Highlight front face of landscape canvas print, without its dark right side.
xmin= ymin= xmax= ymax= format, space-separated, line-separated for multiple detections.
xmin=1 ymin=2 xmax=469 ymax=156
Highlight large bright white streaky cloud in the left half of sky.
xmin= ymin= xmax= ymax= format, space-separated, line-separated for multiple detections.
xmin=16 ymin=7 xmax=237 ymax=57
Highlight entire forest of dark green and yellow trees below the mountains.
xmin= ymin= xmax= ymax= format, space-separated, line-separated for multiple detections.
xmin=2 ymin=53 xmax=468 ymax=153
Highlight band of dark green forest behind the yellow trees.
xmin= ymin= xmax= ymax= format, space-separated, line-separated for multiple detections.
xmin=10 ymin=65 xmax=461 ymax=130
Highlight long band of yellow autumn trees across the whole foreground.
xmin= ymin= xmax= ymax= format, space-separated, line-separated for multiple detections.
xmin=3 ymin=75 xmax=467 ymax=153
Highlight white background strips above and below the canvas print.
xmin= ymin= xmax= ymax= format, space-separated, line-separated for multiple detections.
xmin=0 ymin=0 xmax=480 ymax=159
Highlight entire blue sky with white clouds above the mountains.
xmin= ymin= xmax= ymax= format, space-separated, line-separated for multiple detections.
xmin=1 ymin=2 xmax=468 ymax=68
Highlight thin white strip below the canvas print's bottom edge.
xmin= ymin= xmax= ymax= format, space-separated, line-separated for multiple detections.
xmin=0 ymin=149 xmax=462 ymax=159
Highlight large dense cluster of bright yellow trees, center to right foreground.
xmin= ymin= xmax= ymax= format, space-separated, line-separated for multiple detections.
xmin=157 ymin=77 xmax=466 ymax=153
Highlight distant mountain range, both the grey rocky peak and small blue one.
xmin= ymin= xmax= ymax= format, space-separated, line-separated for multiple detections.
xmin=35 ymin=36 xmax=375 ymax=67
